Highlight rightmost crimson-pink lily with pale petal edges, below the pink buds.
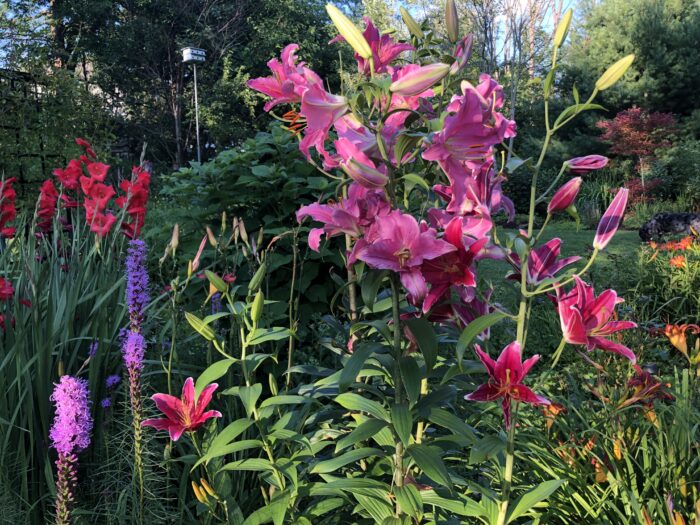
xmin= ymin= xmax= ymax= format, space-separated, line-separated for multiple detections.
xmin=557 ymin=276 xmax=637 ymax=363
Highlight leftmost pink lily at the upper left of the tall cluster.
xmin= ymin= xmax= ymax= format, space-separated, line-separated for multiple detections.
xmin=247 ymin=44 xmax=322 ymax=111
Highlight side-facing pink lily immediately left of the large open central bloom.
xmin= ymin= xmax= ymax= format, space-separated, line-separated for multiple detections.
xmin=297 ymin=183 xmax=390 ymax=252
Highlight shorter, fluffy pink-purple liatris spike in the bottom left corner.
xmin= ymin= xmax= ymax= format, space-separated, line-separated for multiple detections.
xmin=49 ymin=375 xmax=93 ymax=525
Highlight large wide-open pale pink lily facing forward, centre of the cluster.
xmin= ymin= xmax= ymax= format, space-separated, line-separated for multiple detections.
xmin=350 ymin=210 xmax=457 ymax=304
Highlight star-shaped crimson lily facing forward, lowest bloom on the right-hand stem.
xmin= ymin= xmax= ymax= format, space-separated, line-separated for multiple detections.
xmin=464 ymin=341 xmax=550 ymax=428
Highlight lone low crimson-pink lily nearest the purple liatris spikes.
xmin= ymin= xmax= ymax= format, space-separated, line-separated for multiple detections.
xmin=141 ymin=377 xmax=221 ymax=441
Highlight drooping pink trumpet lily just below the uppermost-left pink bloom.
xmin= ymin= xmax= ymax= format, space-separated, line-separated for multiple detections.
xmin=299 ymin=84 xmax=348 ymax=167
